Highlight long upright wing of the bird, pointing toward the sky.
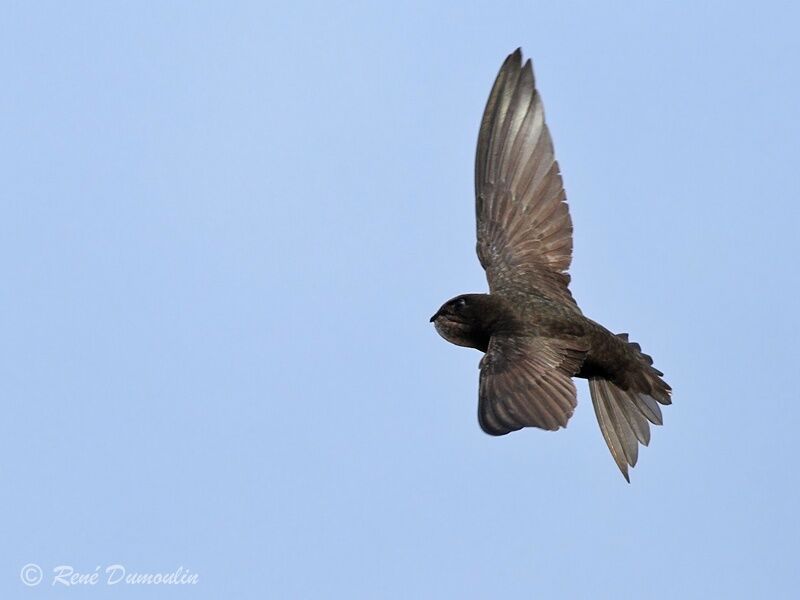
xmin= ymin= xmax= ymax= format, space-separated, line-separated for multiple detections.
xmin=475 ymin=49 xmax=578 ymax=310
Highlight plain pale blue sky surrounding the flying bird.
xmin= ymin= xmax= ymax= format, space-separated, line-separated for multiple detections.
xmin=0 ymin=2 xmax=800 ymax=599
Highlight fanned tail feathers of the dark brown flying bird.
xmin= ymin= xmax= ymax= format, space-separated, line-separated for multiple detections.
xmin=589 ymin=334 xmax=672 ymax=483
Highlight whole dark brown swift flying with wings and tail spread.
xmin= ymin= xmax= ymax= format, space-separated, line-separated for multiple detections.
xmin=431 ymin=49 xmax=671 ymax=481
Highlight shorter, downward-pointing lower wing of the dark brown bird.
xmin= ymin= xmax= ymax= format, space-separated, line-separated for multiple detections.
xmin=478 ymin=335 xmax=586 ymax=435
